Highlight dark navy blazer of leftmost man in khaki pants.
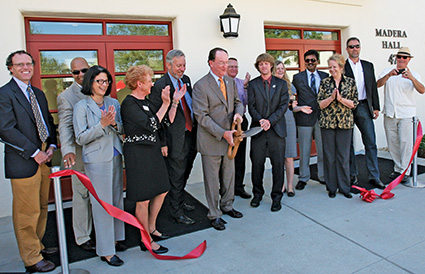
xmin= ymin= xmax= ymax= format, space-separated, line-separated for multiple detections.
xmin=0 ymin=78 xmax=56 ymax=179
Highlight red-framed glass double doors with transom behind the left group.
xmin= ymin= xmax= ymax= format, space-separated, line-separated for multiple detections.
xmin=25 ymin=18 xmax=173 ymax=166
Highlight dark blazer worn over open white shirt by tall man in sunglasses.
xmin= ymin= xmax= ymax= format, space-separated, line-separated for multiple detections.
xmin=345 ymin=59 xmax=381 ymax=118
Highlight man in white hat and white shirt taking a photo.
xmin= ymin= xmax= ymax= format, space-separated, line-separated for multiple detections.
xmin=377 ymin=47 xmax=425 ymax=183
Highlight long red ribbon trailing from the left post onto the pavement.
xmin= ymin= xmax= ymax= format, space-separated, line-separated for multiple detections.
xmin=49 ymin=169 xmax=207 ymax=260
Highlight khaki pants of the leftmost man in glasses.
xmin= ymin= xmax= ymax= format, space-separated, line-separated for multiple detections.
xmin=11 ymin=165 xmax=50 ymax=266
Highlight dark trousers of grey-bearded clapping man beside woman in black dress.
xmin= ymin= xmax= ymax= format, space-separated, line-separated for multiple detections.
xmin=165 ymin=131 xmax=196 ymax=218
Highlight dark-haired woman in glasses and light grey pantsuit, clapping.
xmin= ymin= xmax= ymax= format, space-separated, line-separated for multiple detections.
xmin=74 ymin=66 xmax=127 ymax=266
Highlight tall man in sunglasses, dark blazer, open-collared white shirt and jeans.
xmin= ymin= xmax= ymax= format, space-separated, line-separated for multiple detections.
xmin=345 ymin=37 xmax=385 ymax=189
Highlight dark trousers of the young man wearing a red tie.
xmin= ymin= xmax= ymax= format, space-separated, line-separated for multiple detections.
xmin=250 ymin=128 xmax=285 ymax=201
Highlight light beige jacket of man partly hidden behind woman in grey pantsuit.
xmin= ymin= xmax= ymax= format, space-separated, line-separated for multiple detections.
xmin=57 ymin=82 xmax=87 ymax=170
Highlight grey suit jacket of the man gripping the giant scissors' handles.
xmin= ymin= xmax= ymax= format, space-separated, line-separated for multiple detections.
xmin=192 ymin=72 xmax=243 ymax=156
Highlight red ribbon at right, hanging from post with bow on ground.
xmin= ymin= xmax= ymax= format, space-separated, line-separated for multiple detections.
xmin=351 ymin=122 xmax=423 ymax=203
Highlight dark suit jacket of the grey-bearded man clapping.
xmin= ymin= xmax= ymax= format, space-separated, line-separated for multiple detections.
xmin=150 ymin=73 xmax=197 ymax=157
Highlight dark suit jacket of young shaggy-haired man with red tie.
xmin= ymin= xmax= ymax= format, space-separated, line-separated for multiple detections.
xmin=248 ymin=76 xmax=289 ymax=138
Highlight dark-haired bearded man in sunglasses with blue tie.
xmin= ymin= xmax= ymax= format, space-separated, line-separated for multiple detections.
xmin=292 ymin=49 xmax=329 ymax=190
